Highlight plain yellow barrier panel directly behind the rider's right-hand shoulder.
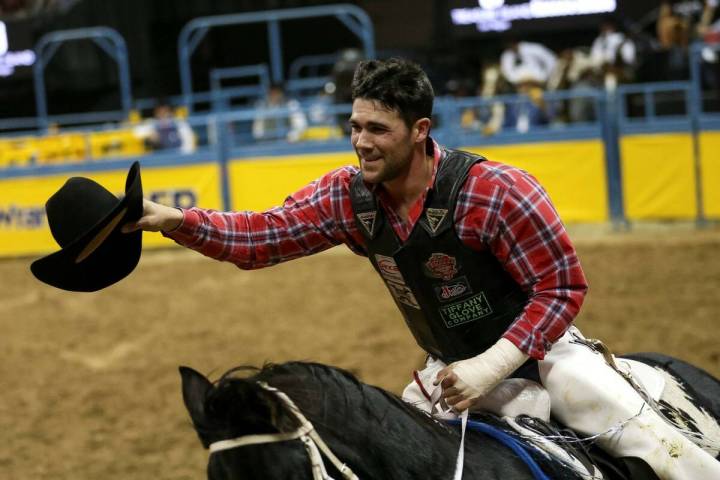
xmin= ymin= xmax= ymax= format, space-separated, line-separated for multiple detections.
xmin=462 ymin=139 xmax=609 ymax=223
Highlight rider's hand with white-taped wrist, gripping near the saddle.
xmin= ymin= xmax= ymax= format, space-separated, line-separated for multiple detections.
xmin=435 ymin=338 xmax=528 ymax=412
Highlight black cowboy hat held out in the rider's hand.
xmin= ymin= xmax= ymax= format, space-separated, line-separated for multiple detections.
xmin=30 ymin=162 xmax=143 ymax=292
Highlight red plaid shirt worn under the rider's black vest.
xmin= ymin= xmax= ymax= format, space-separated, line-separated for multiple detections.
xmin=165 ymin=144 xmax=587 ymax=359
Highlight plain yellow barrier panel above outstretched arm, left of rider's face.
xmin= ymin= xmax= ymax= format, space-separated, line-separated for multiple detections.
xmin=228 ymin=152 xmax=357 ymax=211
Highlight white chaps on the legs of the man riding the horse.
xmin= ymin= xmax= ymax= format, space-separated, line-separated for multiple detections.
xmin=403 ymin=327 xmax=720 ymax=480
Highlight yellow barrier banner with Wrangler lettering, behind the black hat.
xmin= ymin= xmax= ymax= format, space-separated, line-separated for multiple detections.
xmin=0 ymin=164 xmax=222 ymax=256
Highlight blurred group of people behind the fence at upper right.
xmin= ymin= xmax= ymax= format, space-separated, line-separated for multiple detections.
xmin=446 ymin=0 xmax=720 ymax=134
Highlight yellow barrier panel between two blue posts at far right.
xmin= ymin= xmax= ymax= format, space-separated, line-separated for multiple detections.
xmin=620 ymin=133 xmax=697 ymax=220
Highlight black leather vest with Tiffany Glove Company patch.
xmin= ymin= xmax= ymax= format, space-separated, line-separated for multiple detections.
xmin=350 ymin=149 xmax=528 ymax=363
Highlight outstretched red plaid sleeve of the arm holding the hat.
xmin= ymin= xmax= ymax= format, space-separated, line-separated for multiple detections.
xmin=163 ymin=167 xmax=364 ymax=270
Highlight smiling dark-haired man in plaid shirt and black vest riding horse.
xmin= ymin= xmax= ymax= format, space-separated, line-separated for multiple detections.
xmin=126 ymin=59 xmax=720 ymax=478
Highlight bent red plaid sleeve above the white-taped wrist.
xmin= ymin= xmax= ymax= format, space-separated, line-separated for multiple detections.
xmin=456 ymin=162 xmax=588 ymax=360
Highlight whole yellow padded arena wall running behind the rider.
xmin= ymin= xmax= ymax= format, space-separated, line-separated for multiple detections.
xmin=0 ymin=132 xmax=720 ymax=256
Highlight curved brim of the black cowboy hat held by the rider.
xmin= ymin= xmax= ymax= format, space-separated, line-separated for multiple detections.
xmin=30 ymin=162 xmax=143 ymax=292
